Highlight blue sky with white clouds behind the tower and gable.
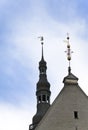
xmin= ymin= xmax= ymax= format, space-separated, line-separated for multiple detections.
xmin=0 ymin=0 xmax=88 ymax=130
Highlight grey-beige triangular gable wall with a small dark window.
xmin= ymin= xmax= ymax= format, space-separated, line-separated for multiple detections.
xmin=35 ymin=74 xmax=88 ymax=130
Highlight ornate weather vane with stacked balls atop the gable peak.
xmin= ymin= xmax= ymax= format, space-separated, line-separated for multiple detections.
xmin=65 ymin=33 xmax=73 ymax=74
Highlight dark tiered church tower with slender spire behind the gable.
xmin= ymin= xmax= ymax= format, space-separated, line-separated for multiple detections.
xmin=29 ymin=37 xmax=51 ymax=130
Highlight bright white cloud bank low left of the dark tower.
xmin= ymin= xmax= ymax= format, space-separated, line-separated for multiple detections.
xmin=0 ymin=104 xmax=33 ymax=130
